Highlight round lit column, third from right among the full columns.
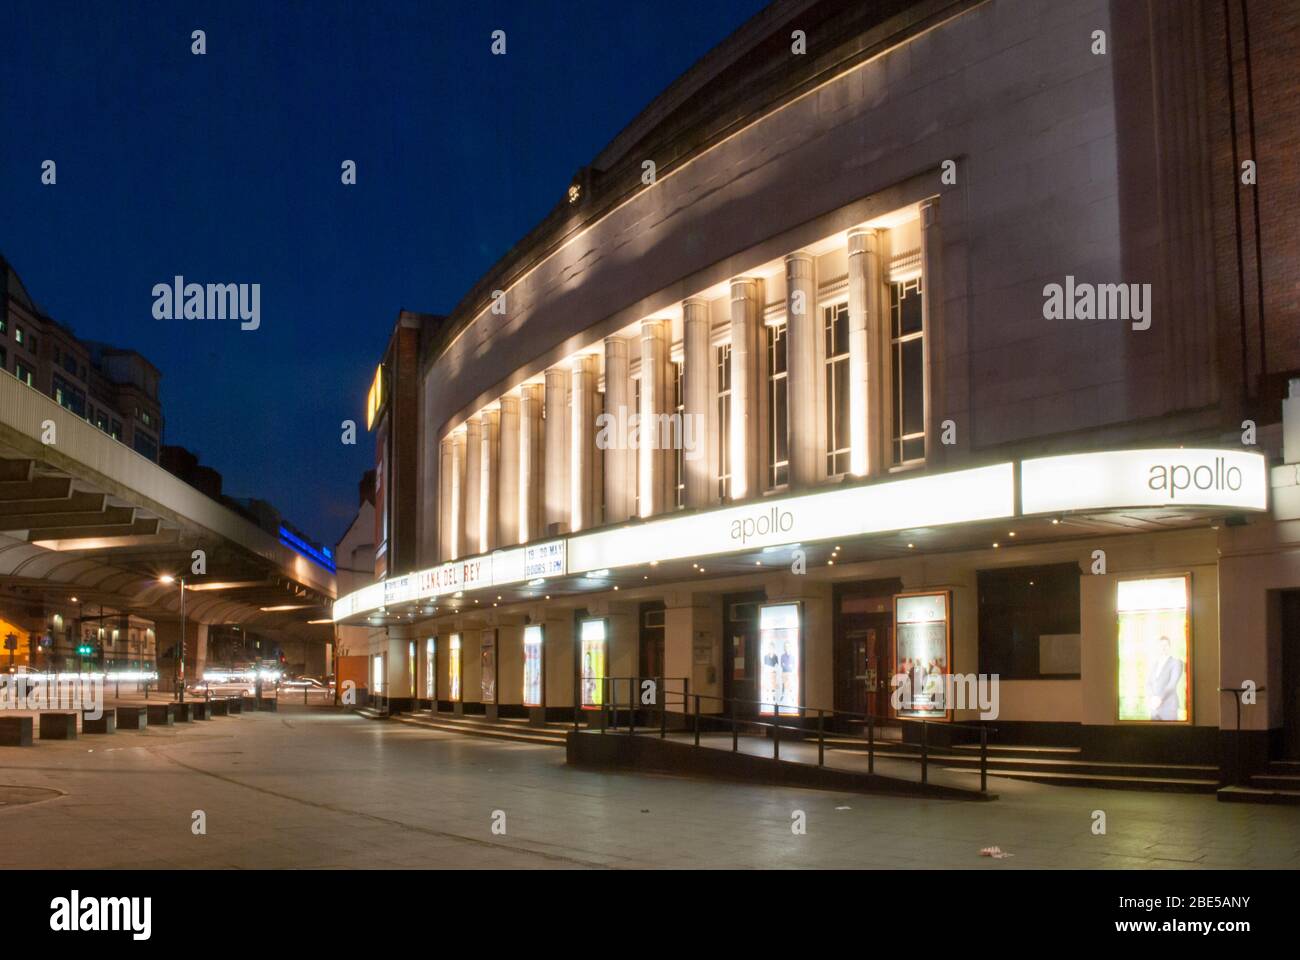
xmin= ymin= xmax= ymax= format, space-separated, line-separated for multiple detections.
xmin=731 ymin=277 xmax=763 ymax=500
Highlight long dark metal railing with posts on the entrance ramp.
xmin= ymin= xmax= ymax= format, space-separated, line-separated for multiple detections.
xmin=573 ymin=676 xmax=996 ymax=793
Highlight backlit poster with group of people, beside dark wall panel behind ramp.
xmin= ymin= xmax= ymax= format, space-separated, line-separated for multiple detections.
xmin=893 ymin=591 xmax=952 ymax=719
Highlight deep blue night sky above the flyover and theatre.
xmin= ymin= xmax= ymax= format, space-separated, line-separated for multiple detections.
xmin=0 ymin=0 xmax=764 ymax=541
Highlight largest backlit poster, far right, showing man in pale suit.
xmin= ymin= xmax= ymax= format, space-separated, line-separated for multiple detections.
xmin=1115 ymin=576 xmax=1192 ymax=723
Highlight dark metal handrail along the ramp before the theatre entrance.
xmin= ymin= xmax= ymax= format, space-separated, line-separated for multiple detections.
xmin=585 ymin=676 xmax=997 ymax=793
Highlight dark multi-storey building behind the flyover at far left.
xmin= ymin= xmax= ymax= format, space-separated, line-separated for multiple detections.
xmin=0 ymin=256 xmax=163 ymax=462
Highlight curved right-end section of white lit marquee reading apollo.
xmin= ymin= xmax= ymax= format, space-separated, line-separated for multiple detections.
xmin=1021 ymin=449 xmax=1268 ymax=514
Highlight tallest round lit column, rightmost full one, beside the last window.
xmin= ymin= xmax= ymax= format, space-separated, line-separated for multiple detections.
xmin=849 ymin=229 xmax=887 ymax=476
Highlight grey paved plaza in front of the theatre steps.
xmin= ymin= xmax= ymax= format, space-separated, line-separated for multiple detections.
xmin=0 ymin=704 xmax=1300 ymax=870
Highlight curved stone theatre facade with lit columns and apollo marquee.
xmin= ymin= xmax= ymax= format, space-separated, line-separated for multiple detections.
xmin=335 ymin=0 xmax=1300 ymax=780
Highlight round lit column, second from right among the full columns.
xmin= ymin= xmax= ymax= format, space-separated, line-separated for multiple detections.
xmin=785 ymin=251 xmax=826 ymax=488
